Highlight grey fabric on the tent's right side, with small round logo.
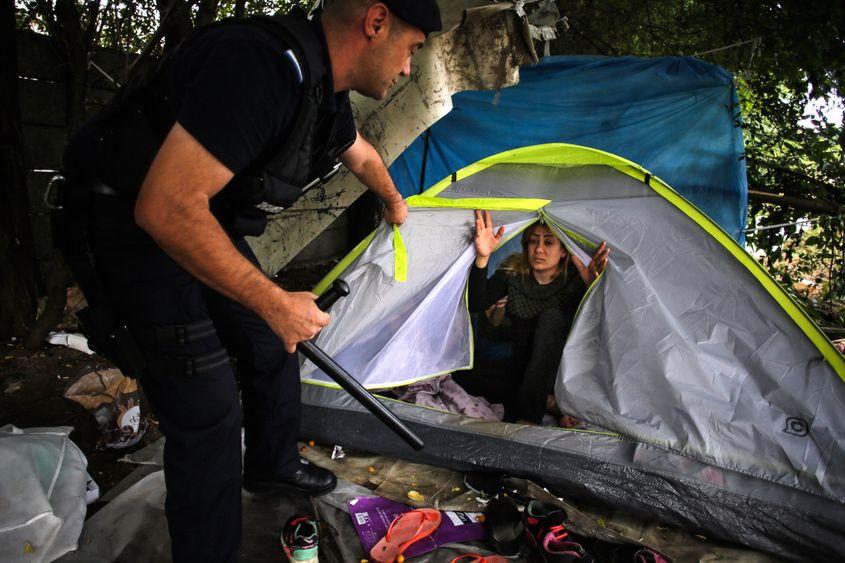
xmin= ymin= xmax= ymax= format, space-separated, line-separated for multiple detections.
xmin=436 ymin=165 xmax=845 ymax=502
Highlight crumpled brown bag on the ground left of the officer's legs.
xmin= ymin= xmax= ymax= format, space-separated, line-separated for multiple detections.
xmin=64 ymin=369 xmax=149 ymax=449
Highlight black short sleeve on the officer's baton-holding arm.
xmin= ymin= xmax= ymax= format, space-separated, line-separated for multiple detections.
xmin=177 ymin=39 xmax=301 ymax=174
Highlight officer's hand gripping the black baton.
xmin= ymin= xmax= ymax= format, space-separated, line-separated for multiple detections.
xmin=265 ymin=291 xmax=331 ymax=353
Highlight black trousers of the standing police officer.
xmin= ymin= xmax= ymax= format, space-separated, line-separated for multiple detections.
xmin=93 ymin=239 xmax=300 ymax=562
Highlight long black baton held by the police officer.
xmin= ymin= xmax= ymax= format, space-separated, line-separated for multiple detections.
xmin=297 ymin=280 xmax=425 ymax=450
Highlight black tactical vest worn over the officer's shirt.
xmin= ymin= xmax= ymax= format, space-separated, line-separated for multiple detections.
xmin=66 ymin=13 xmax=352 ymax=236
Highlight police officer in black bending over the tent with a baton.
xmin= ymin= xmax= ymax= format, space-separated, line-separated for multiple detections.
xmin=57 ymin=0 xmax=441 ymax=561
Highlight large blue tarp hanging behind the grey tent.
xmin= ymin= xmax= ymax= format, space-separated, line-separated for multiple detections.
xmin=390 ymin=56 xmax=748 ymax=240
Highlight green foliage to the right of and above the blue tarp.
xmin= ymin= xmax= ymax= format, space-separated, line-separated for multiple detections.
xmin=552 ymin=0 xmax=845 ymax=326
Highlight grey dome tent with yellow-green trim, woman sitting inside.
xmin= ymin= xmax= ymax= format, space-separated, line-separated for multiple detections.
xmin=302 ymin=144 xmax=845 ymax=560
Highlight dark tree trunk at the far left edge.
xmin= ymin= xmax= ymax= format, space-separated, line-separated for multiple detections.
xmin=0 ymin=6 xmax=38 ymax=340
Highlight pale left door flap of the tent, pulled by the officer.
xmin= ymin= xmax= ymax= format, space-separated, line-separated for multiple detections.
xmin=302 ymin=206 xmax=538 ymax=389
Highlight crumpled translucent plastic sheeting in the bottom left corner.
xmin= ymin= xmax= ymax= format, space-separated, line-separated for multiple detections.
xmin=0 ymin=425 xmax=90 ymax=562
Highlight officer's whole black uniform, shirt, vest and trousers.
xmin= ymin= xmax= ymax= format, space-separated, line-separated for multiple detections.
xmin=59 ymin=13 xmax=356 ymax=561
